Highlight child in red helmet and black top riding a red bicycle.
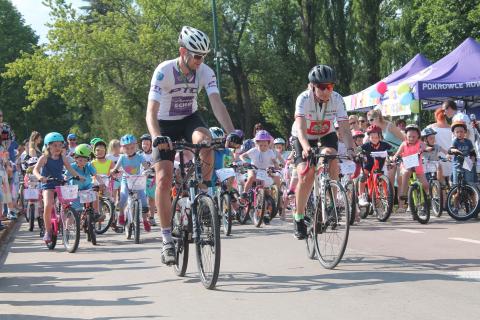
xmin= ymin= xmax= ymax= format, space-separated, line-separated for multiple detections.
xmin=354 ymin=124 xmax=392 ymax=207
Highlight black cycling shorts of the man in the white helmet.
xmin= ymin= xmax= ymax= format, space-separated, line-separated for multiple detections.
xmin=152 ymin=111 xmax=208 ymax=163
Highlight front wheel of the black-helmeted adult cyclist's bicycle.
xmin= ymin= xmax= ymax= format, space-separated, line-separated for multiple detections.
xmin=313 ymin=180 xmax=350 ymax=269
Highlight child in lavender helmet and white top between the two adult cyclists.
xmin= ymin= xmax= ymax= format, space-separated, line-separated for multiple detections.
xmin=240 ymin=130 xmax=281 ymax=199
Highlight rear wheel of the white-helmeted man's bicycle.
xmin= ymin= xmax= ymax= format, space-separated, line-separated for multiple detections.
xmin=171 ymin=196 xmax=188 ymax=277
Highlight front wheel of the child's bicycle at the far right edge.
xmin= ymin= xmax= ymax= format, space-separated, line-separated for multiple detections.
xmin=447 ymin=184 xmax=480 ymax=221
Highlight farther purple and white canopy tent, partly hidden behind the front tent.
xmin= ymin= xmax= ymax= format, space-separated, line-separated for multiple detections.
xmin=343 ymin=53 xmax=432 ymax=112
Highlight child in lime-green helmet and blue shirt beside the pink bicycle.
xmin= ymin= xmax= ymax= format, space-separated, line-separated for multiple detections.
xmin=67 ymin=143 xmax=105 ymax=221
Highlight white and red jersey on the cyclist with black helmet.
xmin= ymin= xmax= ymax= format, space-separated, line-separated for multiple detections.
xmin=292 ymin=88 xmax=348 ymax=140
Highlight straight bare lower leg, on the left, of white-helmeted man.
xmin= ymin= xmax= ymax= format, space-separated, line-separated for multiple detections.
xmin=154 ymin=160 xmax=173 ymax=228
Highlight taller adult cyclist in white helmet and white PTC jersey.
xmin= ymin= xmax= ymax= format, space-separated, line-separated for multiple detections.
xmin=146 ymin=26 xmax=234 ymax=265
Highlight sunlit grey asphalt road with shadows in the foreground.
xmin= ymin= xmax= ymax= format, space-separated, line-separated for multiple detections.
xmin=0 ymin=210 xmax=480 ymax=320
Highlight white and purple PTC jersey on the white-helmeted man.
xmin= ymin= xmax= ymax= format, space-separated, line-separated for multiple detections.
xmin=148 ymin=59 xmax=219 ymax=120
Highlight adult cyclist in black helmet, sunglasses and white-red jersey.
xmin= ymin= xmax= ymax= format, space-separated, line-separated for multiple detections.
xmin=292 ymin=65 xmax=354 ymax=240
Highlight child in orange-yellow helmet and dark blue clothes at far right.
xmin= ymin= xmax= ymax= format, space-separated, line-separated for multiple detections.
xmin=448 ymin=121 xmax=476 ymax=184
